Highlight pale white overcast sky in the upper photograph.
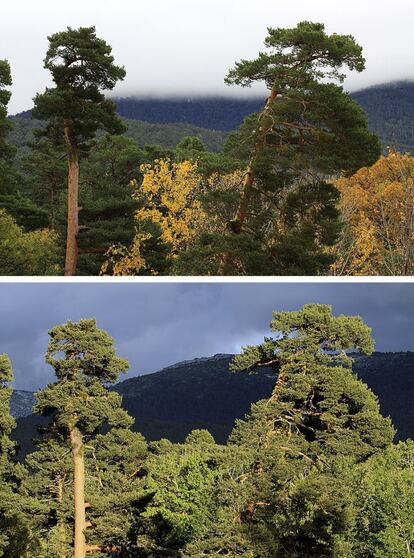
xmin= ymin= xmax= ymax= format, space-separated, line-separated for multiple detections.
xmin=0 ymin=0 xmax=414 ymax=114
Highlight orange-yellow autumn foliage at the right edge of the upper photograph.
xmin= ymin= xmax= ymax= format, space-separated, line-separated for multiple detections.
xmin=332 ymin=152 xmax=414 ymax=275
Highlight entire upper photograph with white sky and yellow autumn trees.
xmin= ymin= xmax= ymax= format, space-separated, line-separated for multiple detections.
xmin=0 ymin=0 xmax=414 ymax=280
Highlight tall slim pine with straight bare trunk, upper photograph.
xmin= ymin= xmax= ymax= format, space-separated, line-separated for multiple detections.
xmin=33 ymin=27 xmax=125 ymax=275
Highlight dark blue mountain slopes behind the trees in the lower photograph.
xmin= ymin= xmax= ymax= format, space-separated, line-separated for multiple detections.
xmin=12 ymin=352 xmax=414 ymax=462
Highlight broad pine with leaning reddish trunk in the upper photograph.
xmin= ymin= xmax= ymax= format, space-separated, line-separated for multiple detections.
xmin=219 ymin=22 xmax=380 ymax=274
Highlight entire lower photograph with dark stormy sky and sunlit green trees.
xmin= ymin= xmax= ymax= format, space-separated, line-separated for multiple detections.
xmin=0 ymin=282 xmax=414 ymax=558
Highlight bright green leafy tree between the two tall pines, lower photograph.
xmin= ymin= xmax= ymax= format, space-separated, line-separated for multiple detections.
xmin=136 ymin=430 xmax=221 ymax=556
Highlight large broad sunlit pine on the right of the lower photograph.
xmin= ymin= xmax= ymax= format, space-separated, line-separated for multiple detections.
xmin=205 ymin=304 xmax=394 ymax=558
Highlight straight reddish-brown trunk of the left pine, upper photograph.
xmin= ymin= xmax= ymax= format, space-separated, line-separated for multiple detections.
xmin=65 ymin=122 xmax=79 ymax=276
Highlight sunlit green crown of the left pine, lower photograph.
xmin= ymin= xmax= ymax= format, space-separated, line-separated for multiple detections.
xmin=34 ymin=319 xmax=131 ymax=442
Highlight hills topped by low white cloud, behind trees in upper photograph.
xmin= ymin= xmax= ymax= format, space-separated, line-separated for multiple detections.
xmin=11 ymin=81 xmax=414 ymax=153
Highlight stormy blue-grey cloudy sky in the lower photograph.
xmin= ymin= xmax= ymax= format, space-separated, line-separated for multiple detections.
xmin=0 ymin=282 xmax=414 ymax=390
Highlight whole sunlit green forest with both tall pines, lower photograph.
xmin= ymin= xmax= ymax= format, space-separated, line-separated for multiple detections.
xmin=0 ymin=304 xmax=414 ymax=558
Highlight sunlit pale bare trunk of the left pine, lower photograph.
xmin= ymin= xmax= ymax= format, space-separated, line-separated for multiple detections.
xmin=70 ymin=427 xmax=86 ymax=558
